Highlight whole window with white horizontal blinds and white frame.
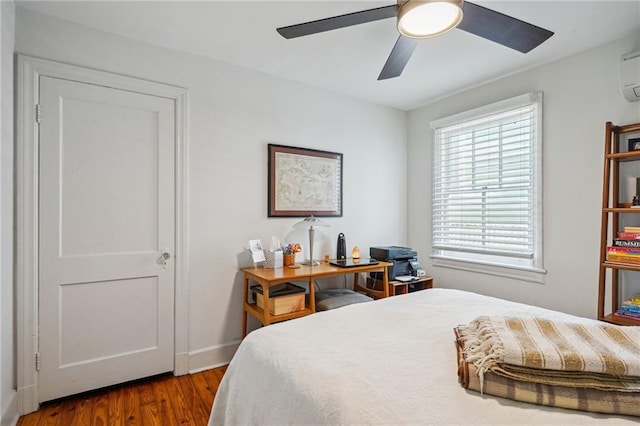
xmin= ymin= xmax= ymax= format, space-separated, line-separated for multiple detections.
xmin=431 ymin=93 xmax=544 ymax=282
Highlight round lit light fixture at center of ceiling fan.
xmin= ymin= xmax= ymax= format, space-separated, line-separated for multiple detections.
xmin=398 ymin=0 xmax=462 ymax=38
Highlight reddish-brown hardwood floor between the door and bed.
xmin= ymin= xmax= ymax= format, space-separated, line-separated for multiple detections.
xmin=18 ymin=366 xmax=227 ymax=426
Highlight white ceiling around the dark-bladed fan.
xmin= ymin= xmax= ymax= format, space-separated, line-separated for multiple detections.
xmin=17 ymin=0 xmax=640 ymax=110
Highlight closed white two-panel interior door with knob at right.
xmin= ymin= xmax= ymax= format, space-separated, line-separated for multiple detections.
xmin=38 ymin=77 xmax=175 ymax=402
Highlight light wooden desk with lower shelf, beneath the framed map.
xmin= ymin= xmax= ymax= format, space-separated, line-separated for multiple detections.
xmin=241 ymin=262 xmax=392 ymax=337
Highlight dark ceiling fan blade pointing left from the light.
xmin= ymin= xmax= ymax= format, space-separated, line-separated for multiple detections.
xmin=276 ymin=4 xmax=398 ymax=39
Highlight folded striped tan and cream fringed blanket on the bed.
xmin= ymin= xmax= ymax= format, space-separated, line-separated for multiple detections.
xmin=454 ymin=317 xmax=640 ymax=416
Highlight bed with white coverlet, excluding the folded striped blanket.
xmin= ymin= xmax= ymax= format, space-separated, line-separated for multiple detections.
xmin=209 ymin=289 xmax=640 ymax=425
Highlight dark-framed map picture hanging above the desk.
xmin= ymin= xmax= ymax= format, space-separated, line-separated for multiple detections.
xmin=267 ymin=144 xmax=342 ymax=217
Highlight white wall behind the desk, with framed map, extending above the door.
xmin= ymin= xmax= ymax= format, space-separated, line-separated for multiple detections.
xmin=15 ymin=7 xmax=407 ymax=369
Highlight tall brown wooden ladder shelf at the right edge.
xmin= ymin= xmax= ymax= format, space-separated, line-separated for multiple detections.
xmin=598 ymin=122 xmax=640 ymax=326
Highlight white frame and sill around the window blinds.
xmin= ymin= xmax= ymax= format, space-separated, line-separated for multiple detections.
xmin=429 ymin=92 xmax=546 ymax=283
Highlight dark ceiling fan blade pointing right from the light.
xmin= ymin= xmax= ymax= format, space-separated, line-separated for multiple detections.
xmin=458 ymin=1 xmax=553 ymax=53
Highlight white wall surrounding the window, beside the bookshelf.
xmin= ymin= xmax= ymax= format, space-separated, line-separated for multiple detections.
xmin=408 ymin=34 xmax=640 ymax=317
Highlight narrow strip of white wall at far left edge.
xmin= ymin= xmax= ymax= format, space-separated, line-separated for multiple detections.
xmin=0 ymin=1 xmax=17 ymax=426
